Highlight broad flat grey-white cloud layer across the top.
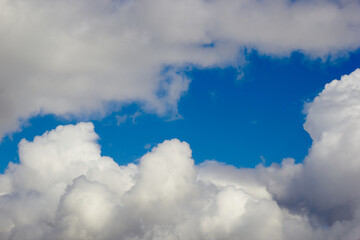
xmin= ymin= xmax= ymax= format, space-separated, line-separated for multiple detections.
xmin=0 ymin=0 xmax=360 ymax=138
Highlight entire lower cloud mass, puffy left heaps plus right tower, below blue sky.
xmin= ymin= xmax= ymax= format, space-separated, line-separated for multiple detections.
xmin=0 ymin=70 xmax=360 ymax=240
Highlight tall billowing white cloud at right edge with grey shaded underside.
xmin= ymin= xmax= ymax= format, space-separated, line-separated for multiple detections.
xmin=278 ymin=69 xmax=360 ymax=224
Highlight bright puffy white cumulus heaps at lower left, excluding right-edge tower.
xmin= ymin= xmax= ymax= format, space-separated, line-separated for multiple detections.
xmin=0 ymin=123 xmax=316 ymax=239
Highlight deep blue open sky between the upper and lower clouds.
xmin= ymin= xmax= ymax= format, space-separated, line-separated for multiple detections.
xmin=0 ymin=51 xmax=360 ymax=171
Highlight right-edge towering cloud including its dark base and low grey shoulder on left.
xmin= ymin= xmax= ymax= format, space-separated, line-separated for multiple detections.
xmin=263 ymin=69 xmax=360 ymax=232
